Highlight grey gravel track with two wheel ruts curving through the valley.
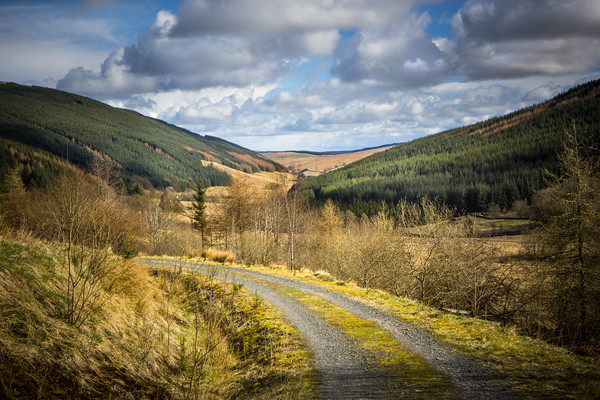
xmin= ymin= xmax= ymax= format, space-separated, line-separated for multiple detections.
xmin=138 ymin=259 xmax=519 ymax=399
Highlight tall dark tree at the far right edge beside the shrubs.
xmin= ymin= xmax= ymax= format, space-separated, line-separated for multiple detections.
xmin=541 ymin=124 xmax=600 ymax=344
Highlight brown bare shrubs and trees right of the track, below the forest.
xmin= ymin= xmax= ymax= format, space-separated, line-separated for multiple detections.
xmin=207 ymin=128 xmax=600 ymax=351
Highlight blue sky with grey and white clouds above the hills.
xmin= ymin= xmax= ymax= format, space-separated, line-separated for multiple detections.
xmin=0 ymin=0 xmax=600 ymax=151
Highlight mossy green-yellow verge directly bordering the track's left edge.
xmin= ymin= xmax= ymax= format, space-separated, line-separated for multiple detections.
xmin=159 ymin=269 xmax=316 ymax=399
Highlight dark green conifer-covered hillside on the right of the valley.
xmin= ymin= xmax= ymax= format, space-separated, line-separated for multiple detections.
xmin=306 ymin=81 xmax=600 ymax=215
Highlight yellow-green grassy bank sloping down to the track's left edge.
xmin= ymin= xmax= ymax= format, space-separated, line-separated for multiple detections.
xmin=0 ymin=238 xmax=315 ymax=399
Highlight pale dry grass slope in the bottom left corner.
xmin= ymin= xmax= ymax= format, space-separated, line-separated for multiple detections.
xmin=0 ymin=241 xmax=168 ymax=398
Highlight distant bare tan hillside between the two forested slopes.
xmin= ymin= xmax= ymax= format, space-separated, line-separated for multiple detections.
xmin=260 ymin=145 xmax=395 ymax=176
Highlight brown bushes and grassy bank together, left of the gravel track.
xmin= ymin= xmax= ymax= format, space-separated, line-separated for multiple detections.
xmin=0 ymin=165 xmax=312 ymax=399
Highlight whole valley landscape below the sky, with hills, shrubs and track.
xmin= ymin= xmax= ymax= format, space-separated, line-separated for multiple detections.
xmin=0 ymin=81 xmax=600 ymax=399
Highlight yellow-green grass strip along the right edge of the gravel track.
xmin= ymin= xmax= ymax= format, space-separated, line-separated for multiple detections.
xmin=142 ymin=255 xmax=600 ymax=399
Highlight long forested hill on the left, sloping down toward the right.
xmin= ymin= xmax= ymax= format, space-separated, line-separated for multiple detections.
xmin=0 ymin=83 xmax=285 ymax=189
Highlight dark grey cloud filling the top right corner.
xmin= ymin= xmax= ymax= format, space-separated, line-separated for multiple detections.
xmin=452 ymin=0 xmax=600 ymax=79
